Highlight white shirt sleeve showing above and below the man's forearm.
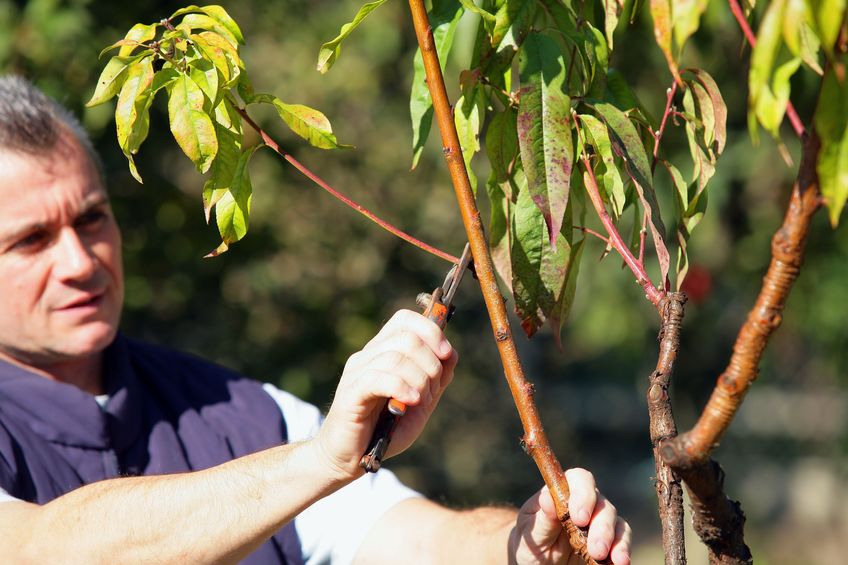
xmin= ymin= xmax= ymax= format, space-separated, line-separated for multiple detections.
xmin=264 ymin=384 xmax=421 ymax=565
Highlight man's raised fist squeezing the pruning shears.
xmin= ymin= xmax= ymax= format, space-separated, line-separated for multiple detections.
xmin=316 ymin=310 xmax=458 ymax=479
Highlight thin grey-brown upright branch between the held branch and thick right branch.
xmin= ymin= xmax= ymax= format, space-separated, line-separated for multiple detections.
xmin=648 ymin=292 xmax=686 ymax=565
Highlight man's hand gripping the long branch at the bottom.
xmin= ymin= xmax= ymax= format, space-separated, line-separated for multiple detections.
xmin=509 ymin=469 xmax=631 ymax=565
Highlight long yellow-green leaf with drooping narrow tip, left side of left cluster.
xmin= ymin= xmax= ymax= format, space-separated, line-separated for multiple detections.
xmin=115 ymin=55 xmax=154 ymax=182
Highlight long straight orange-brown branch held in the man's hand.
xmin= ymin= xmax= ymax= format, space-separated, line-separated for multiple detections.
xmin=409 ymin=0 xmax=608 ymax=564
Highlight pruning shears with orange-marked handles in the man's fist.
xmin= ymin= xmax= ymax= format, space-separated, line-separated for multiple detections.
xmin=359 ymin=243 xmax=471 ymax=473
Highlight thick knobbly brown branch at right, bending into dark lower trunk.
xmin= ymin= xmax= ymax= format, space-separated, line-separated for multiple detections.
xmin=659 ymin=130 xmax=822 ymax=564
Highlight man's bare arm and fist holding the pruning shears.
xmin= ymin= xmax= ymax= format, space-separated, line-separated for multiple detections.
xmin=0 ymin=311 xmax=456 ymax=564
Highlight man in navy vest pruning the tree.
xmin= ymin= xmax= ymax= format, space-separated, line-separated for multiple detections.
xmin=0 ymin=78 xmax=630 ymax=565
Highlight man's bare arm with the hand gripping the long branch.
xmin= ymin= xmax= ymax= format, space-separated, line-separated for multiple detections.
xmin=355 ymin=469 xmax=631 ymax=565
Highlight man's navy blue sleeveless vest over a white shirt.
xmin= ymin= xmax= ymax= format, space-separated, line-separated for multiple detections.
xmin=0 ymin=335 xmax=303 ymax=565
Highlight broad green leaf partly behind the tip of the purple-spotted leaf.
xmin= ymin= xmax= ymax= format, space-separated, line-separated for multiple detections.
xmin=510 ymin=174 xmax=572 ymax=337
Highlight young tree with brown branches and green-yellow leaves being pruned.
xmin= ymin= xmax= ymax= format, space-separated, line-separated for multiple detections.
xmin=89 ymin=0 xmax=848 ymax=563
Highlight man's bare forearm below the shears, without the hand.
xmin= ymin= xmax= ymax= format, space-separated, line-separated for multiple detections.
xmin=0 ymin=442 xmax=344 ymax=564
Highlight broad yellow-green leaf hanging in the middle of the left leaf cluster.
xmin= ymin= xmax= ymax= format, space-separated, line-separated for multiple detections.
xmin=168 ymin=74 xmax=218 ymax=173
